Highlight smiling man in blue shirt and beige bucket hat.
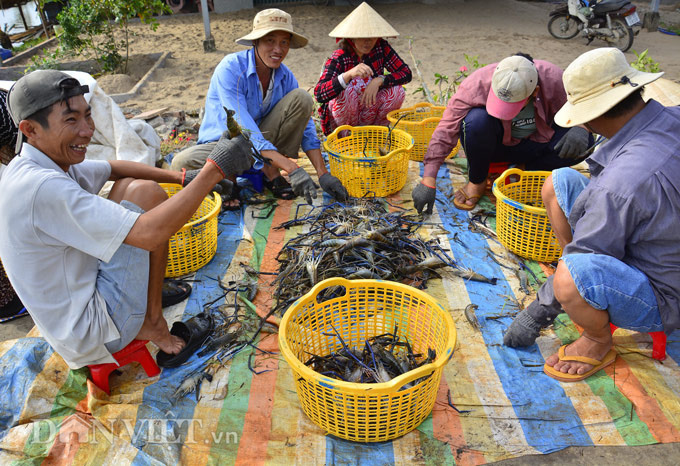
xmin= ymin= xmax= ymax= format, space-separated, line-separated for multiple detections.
xmin=172 ymin=8 xmax=348 ymax=204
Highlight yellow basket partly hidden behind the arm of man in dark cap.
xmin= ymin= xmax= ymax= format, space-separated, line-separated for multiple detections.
xmin=161 ymin=183 xmax=222 ymax=277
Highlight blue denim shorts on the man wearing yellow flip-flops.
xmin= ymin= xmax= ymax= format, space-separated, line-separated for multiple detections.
xmin=552 ymin=168 xmax=663 ymax=332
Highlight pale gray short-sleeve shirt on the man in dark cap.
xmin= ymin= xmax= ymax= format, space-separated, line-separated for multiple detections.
xmin=0 ymin=143 xmax=140 ymax=369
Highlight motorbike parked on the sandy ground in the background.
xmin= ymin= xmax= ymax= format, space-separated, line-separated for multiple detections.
xmin=548 ymin=0 xmax=640 ymax=52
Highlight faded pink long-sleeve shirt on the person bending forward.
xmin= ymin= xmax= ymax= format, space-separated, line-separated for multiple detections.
xmin=423 ymin=60 xmax=567 ymax=177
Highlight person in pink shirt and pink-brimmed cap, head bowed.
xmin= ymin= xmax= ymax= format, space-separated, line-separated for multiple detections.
xmin=412 ymin=52 xmax=593 ymax=212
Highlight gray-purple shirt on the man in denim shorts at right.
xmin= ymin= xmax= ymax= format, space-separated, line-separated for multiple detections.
xmin=564 ymin=100 xmax=680 ymax=332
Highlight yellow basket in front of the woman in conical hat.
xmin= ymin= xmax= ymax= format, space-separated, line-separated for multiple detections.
xmin=323 ymin=125 xmax=413 ymax=197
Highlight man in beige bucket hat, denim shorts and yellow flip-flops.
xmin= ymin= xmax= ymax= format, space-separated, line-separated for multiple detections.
xmin=504 ymin=48 xmax=680 ymax=382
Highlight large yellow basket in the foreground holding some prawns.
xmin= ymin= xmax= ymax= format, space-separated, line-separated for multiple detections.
xmin=279 ymin=278 xmax=456 ymax=442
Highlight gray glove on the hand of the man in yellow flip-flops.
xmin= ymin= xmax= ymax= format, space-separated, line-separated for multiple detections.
xmin=503 ymin=275 xmax=563 ymax=348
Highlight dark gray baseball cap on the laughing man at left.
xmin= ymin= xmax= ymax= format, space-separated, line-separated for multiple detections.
xmin=7 ymin=70 xmax=89 ymax=154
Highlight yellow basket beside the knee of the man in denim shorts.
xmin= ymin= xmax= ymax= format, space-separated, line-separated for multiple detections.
xmin=493 ymin=168 xmax=562 ymax=262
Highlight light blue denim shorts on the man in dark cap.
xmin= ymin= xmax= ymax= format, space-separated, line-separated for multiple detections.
xmin=97 ymin=201 xmax=149 ymax=353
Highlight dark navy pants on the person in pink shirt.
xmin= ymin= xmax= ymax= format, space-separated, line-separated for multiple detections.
xmin=460 ymin=108 xmax=593 ymax=184
